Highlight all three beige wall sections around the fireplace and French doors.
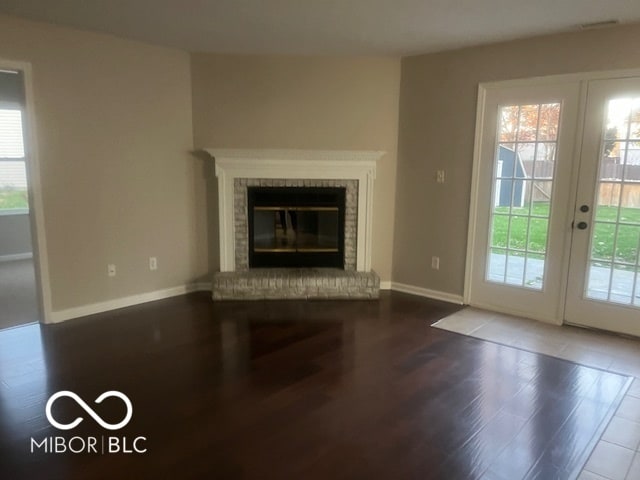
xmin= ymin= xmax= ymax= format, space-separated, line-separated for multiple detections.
xmin=6 ymin=12 xmax=640 ymax=310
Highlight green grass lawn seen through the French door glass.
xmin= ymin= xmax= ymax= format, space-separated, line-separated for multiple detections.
xmin=491 ymin=202 xmax=640 ymax=264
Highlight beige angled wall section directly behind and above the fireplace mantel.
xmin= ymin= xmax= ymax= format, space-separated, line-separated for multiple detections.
xmin=192 ymin=54 xmax=400 ymax=281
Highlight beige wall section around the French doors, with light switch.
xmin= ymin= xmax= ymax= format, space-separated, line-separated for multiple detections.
xmin=393 ymin=25 xmax=640 ymax=294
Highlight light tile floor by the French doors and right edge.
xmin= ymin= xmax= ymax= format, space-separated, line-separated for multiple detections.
xmin=433 ymin=307 xmax=640 ymax=480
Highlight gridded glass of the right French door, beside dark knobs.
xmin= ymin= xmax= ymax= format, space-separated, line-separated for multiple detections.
xmin=585 ymin=97 xmax=640 ymax=307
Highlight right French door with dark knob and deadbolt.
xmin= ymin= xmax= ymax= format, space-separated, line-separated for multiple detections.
xmin=565 ymin=78 xmax=640 ymax=336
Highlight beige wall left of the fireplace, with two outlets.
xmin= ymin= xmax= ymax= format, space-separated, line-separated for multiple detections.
xmin=0 ymin=16 xmax=200 ymax=311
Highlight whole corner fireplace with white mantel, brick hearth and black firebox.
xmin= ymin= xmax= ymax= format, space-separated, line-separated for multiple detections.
xmin=207 ymin=149 xmax=384 ymax=300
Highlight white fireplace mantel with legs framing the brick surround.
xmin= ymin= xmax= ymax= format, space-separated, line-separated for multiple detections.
xmin=205 ymin=148 xmax=385 ymax=272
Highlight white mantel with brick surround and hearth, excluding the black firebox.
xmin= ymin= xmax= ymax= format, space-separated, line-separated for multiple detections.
xmin=206 ymin=149 xmax=384 ymax=300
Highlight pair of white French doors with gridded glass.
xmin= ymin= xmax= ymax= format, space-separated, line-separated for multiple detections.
xmin=465 ymin=79 xmax=640 ymax=335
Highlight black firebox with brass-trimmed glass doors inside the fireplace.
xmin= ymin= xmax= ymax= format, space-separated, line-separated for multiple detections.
xmin=247 ymin=187 xmax=345 ymax=269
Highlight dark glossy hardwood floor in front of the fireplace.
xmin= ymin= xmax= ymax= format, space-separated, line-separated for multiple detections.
xmin=0 ymin=292 xmax=629 ymax=480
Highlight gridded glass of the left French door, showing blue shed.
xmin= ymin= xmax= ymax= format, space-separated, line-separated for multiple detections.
xmin=485 ymin=103 xmax=560 ymax=290
